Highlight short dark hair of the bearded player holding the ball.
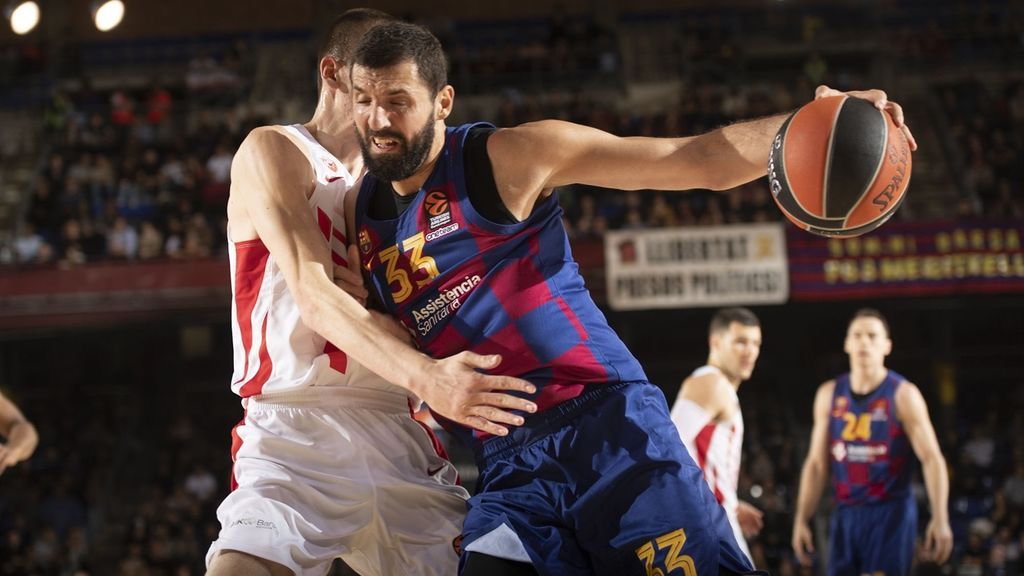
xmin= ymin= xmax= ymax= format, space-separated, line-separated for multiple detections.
xmin=352 ymin=22 xmax=447 ymax=94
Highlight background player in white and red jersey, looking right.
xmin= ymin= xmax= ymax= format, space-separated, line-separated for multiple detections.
xmin=672 ymin=307 xmax=763 ymax=558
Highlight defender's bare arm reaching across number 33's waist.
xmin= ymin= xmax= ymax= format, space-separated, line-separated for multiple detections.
xmin=231 ymin=127 xmax=536 ymax=435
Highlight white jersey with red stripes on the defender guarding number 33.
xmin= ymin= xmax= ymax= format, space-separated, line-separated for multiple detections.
xmin=228 ymin=124 xmax=406 ymax=398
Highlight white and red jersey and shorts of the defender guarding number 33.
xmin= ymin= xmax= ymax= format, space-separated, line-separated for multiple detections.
xmin=215 ymin=126 xmax=469 ymax=576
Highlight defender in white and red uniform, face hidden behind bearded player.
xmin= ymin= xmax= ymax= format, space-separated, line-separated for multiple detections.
xmin=201 ymin=9 xmax=536 ymax=575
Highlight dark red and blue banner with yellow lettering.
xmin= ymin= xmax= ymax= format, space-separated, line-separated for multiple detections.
xmin=787 ymin=220 xmax=1024 ymax=300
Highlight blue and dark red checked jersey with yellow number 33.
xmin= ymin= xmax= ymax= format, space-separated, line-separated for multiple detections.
xmin=355 ymin=124 xmax=646 ymax=440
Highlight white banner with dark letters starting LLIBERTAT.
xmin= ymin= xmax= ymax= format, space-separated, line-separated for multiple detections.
xmin=604 ymin=223 xmax=790 ymax=310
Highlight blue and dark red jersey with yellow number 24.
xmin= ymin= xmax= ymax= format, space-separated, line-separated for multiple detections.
xmin=828 ymin=370 xmax=914 ymax=505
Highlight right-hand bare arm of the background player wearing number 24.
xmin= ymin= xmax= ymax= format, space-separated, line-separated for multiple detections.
xmin=896 ymin=382 xmax=953 ymax=564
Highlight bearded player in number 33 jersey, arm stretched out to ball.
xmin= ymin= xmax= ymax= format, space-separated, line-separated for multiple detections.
xmin=348 ymin=23 xmax=902 ymax=576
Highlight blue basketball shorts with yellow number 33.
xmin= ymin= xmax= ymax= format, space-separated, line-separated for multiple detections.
xmin=462 ymin=382 xmax=753 ymax=576
